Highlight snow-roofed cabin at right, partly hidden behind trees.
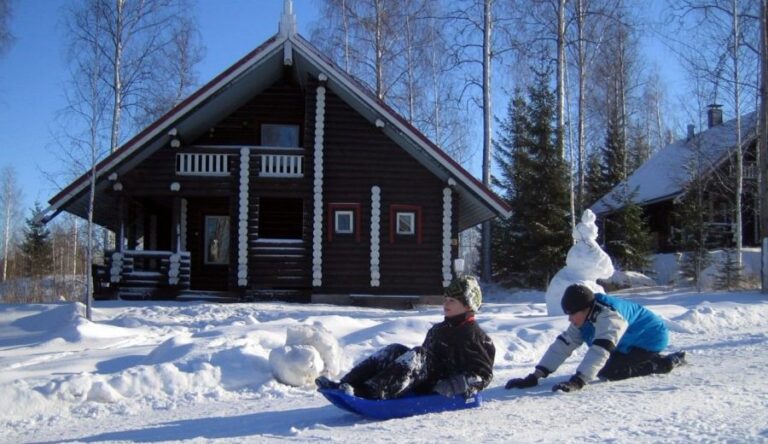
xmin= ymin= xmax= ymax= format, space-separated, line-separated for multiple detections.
xmin=591 ymin=105 xmax=760 ymax=253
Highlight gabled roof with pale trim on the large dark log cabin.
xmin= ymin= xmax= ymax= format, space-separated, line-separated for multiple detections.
xmin=45 ymin=26 xmax=511 ymax=230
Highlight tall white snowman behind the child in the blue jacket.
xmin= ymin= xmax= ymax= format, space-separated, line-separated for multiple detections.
xmin=544 ymin=210 xmax=613 ymax=316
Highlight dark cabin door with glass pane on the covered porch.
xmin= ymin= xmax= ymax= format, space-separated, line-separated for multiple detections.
xmin=187 ymin=199 xmax=235 ymax=291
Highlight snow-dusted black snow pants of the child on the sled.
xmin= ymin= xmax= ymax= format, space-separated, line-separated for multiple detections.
xmin=339 ymin=344 xmax=434 ymax=399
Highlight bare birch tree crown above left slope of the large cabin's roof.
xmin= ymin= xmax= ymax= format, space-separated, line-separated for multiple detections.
xmin=65 ymin=0 xmax=202 ymax=156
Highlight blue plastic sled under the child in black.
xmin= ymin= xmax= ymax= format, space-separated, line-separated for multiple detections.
xmin=318 ymin=389 xmax=482 ymax=419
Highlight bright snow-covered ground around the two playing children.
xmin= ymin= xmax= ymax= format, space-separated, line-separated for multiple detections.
xmin=0 ymin=288 xmax=768 ymax=443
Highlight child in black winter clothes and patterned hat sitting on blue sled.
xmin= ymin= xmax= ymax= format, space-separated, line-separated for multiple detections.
xmin=315 ymin=276 xmax=496 ymax=400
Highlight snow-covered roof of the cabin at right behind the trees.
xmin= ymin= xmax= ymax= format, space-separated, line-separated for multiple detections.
xmin=591 ymin=112 xmax=757 ymax=214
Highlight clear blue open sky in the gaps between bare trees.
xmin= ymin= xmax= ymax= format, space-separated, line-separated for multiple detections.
xmin=0 ymin=0 xmax=682 ymax=222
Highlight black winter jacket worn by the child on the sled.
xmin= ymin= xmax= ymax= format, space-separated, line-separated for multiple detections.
xmin=421 ymin=312 xmax=496 ymax=390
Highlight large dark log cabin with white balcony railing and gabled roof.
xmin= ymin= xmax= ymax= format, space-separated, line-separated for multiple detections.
xmin=40 ymin=6 xmax=510 ymax=302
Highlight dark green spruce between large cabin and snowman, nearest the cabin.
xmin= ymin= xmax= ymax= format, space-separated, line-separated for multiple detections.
xmin=495 ymin=67 xmax=571 ymax=288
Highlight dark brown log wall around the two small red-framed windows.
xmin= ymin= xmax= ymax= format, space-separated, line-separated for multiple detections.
xmin=314 ymin=81 xmax=458 ymax=294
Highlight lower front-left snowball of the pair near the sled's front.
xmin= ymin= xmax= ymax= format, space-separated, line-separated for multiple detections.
xmin=269 ymin=345 xmax=325 ymax=387
